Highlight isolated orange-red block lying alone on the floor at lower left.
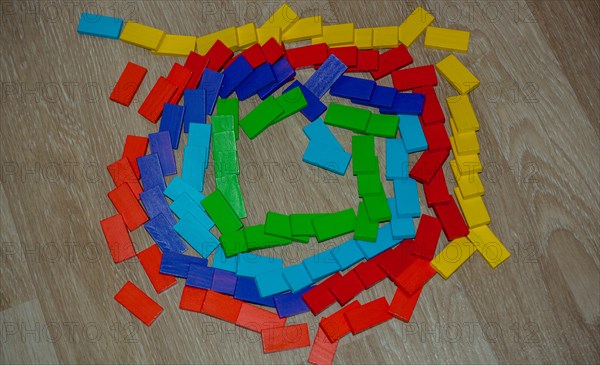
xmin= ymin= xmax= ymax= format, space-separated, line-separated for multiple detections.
xmin=115 ymin=281 xmax=163 ymax=326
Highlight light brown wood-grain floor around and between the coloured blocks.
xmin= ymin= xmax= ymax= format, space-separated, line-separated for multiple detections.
xmin=0 ymin=0 xmax=600 ymax=364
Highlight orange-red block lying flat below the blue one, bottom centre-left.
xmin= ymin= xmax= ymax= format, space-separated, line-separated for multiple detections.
xmin=261 ymin=323 xmax=310 ymax=354
